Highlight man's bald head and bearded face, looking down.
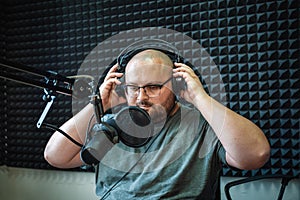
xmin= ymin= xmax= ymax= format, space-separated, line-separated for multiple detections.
xmin=125 ymin=52 xmax=175 ymax=122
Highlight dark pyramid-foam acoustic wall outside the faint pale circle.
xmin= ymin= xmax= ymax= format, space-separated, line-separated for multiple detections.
xmin=0 ymin=0 xmax=300 ymax=176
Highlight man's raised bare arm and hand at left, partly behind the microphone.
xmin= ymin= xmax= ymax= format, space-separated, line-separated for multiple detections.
xmin=44 ymin=65 xmax=126 ymax=168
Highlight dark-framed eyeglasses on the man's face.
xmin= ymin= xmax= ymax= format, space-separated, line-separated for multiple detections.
xmin=123 ymin=77 xmax=173 ymax=98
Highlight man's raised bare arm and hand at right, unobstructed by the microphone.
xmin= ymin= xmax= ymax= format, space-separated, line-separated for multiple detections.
xmin=174 ymin=63 xmax=270 ymax=170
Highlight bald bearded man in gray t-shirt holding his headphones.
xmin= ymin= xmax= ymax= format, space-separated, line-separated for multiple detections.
xmin=45 ymin=49 xmax=270 ymax=200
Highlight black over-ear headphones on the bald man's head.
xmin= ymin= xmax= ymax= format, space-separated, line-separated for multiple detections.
xmin=116 ymin=39 xmax=186 ymax=96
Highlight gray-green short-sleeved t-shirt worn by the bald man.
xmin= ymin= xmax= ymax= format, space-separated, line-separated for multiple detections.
xmin=96 ymin=105 xmax=225 ymax=200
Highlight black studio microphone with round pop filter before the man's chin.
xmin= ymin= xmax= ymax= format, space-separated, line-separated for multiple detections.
xmin=80 ymin=106 xmax=154 ymax=165
